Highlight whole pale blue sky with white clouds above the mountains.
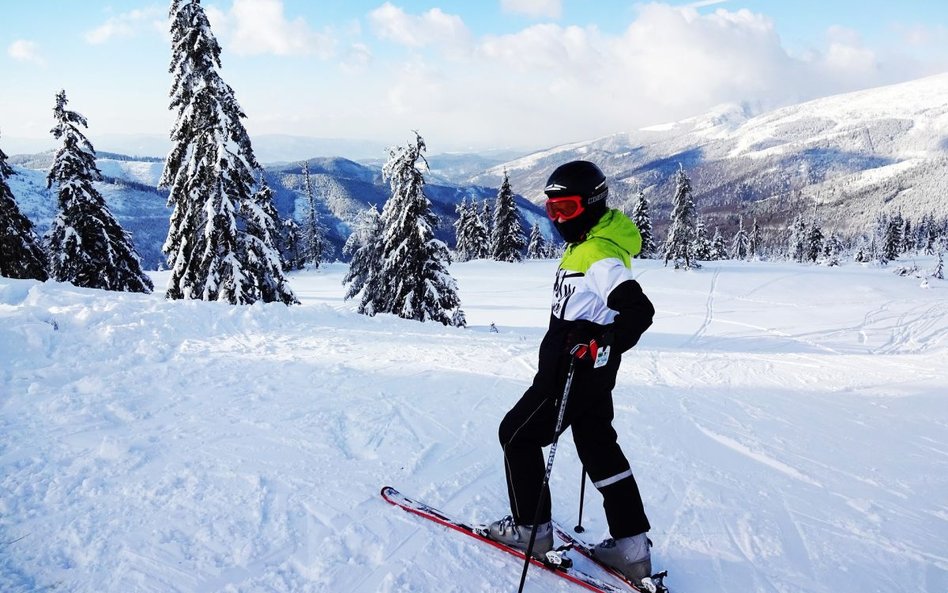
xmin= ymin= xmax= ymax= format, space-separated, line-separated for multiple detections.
xmin=0 ymin=0 xmax=948 ymax=153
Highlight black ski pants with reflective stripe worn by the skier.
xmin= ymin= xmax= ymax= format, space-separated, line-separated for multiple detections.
xmin=499 ymin=355 xmax=650 ymax=539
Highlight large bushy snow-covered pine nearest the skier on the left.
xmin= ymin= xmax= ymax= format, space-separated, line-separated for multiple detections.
xmin=372 ymin=132 xmax=460 ymax=325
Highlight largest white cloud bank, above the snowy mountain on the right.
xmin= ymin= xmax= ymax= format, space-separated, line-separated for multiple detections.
xmin=231 ymin=2 xmax=946 ymax=150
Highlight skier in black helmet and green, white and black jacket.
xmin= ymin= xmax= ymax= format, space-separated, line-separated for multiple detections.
xmin=488 ymin=161 xmax=655 ymax=583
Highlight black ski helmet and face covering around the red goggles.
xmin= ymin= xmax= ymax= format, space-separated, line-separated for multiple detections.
xmin=543 ymin=161 xmax=609 ymax=243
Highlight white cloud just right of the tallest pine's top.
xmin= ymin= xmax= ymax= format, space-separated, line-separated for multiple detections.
xmin=206 ymin=0 xmax=336 ymax=59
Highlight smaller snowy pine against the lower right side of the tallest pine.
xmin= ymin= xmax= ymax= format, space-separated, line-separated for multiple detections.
xmin=240 ymin=175 xmax=299 ymax=305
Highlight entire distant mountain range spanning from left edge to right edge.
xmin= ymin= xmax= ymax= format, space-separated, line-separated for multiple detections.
xmin=9 ymin=73 xmax=948 ymax=269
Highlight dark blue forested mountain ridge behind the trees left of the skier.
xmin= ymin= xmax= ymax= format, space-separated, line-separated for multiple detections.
xmin=8 ymin=151 xmax=553 ymax=269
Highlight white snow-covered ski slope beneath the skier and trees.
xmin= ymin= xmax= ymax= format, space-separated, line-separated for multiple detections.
xmin=0 ymin=262 xmax=948 ymax=593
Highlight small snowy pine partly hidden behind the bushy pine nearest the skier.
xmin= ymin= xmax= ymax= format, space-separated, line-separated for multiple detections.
xmin=342 ymin=206 xmax=384 ymax=315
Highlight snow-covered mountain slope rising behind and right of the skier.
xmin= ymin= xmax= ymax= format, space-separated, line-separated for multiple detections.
xmin=482 ymin=73 xmax=948 ymax=230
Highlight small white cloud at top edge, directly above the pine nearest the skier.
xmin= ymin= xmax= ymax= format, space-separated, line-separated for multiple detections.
xmin=369 ymin=2 xmax=471 ymax=48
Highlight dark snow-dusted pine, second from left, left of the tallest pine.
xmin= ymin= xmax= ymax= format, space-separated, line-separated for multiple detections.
xmin=46 ymin=91 xmax=154 ymax=292
